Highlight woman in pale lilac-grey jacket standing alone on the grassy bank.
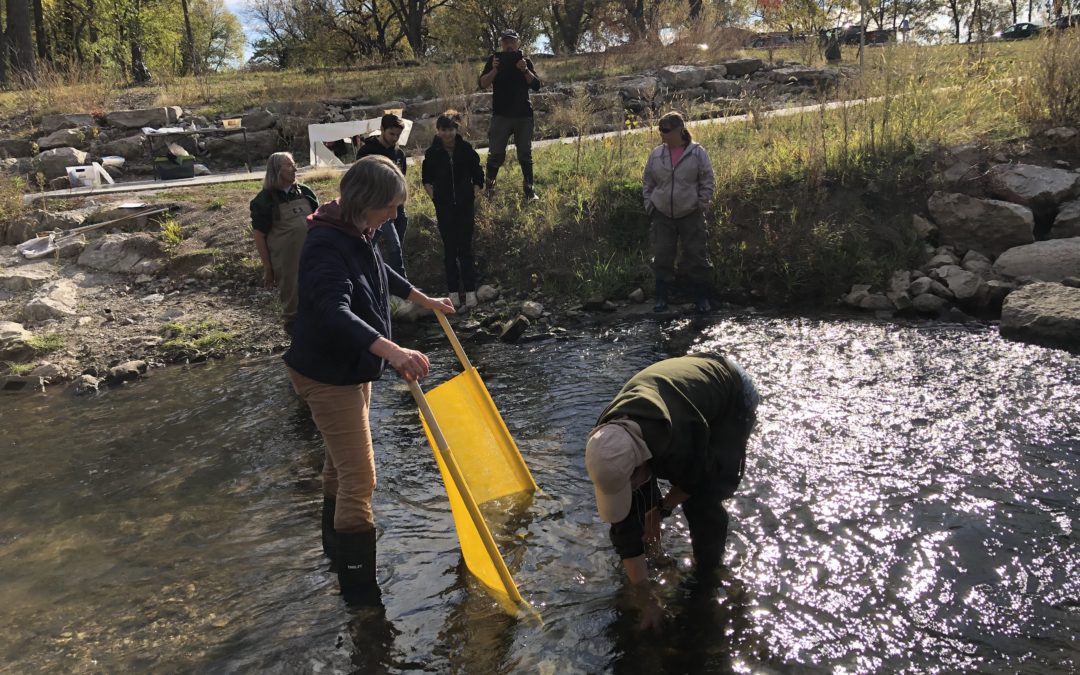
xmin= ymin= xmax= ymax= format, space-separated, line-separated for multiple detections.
xmin=643 ymin=112 xmax=716 ymax=313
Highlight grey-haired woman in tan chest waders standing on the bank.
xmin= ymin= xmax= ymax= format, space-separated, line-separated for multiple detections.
xmin=251 ymin=152 xmax=319 ymax=335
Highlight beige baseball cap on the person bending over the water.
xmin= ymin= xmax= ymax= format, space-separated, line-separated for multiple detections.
xmin=585 ymin=419 xmax=652 ymax=523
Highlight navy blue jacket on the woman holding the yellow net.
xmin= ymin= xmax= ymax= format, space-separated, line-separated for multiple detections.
xmin=282 ymin=200 xmax=413 ymax=384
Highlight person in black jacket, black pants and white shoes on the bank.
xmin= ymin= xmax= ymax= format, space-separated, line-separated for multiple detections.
xmin=421 ymin=110 xmax=484 ymax=308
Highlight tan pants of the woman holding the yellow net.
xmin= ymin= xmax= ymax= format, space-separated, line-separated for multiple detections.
xmin=288 ymin=368 xmax=375 ymax=532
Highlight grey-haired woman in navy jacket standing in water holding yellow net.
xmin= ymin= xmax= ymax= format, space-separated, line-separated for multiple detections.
xmin=283 ymin=157 xmax=454 ymax=605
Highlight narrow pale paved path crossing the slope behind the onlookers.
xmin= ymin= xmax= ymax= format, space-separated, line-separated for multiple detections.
xmin=23 ymin=93 xmax=894 ymax=204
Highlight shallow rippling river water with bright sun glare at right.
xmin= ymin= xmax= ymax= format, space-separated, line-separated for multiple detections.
xmin=0 ymin=314 xmax=1080 ymax=673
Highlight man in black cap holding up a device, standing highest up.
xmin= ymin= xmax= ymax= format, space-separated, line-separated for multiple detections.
xmin=480 ymin=30 xmax=540 ymax=200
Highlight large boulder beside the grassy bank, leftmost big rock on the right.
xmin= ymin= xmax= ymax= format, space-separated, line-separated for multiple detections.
xmin=927 ymin=192 xmax=1035 ymax=256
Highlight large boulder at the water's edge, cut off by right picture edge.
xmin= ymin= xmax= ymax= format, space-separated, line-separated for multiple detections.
xmin=1001 ymin=283 xmax=1080 ymax=349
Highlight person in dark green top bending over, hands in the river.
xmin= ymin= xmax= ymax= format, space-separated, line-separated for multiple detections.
xmin=585 ymin=352 xmax=760 ymax=626
